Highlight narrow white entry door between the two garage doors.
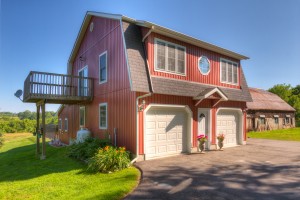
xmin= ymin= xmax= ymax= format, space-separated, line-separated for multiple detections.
xmin=197 ymin=108 xmax=210 ymax=149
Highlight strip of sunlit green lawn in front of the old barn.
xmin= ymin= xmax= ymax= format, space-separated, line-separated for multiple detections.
xmin=248 ymin=127 xmax=300 ymax=141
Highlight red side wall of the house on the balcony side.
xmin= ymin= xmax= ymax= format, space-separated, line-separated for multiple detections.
xmin=60 ymin=17 xmax=136 ymax=153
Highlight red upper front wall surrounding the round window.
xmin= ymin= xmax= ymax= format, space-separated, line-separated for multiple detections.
xmin=142 ymin=29 xmax=240 ymax=88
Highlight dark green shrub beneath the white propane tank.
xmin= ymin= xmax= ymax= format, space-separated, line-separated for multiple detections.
xmin=67 ymin=137 xmax=111 ymax=160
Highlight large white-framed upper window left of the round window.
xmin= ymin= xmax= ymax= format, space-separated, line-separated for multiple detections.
xmin=155 ymin=39 xmax=186 ymax=75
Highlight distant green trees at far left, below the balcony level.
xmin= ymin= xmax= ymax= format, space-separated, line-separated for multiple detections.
xmin=0 ymin=110 xmax=57 ymax=133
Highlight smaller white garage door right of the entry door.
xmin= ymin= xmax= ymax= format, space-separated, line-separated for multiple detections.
xmin=217 ymin=110 xmax=239 ymax=147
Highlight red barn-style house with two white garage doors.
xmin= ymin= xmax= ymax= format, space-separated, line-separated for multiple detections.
xmin=27 ymin=12 xmax=252 ymax=159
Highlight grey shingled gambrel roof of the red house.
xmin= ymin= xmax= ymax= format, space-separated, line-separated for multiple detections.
xmin=68 ymin=12 xmax=252 ymax=102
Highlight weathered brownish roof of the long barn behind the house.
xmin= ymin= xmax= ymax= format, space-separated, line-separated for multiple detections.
xmin=247 ymin=88 xmax=295 ymax=111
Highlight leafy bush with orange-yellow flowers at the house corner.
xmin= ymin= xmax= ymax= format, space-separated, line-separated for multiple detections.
xmin=88 ymin=146 xmax=130 ymax=173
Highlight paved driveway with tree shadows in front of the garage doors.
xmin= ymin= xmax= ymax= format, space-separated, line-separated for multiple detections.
xmin=125 ymin=139 xmax=300 ymax=200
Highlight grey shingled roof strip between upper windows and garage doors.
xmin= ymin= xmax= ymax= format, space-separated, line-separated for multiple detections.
xmin=152 ymin=67 xmax=252 ymax=102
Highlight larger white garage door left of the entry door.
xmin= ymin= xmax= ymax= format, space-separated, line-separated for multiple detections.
xmin=145 ymin=108 xmax=187 ymax=159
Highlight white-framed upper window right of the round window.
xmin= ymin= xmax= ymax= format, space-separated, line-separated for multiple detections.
xmin=220 ymin=58 xmax=238 ymax=85
